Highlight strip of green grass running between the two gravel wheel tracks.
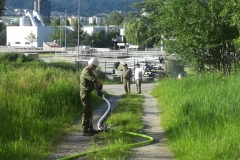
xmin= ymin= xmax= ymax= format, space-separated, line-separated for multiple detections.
xmin=88 ymin=94 xmax=143 ymax=160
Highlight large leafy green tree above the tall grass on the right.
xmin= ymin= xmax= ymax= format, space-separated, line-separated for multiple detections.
xmin=126 ymin=0 xmax=239 ymax=74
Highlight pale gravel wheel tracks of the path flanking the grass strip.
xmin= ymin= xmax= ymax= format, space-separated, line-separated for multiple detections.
xmin=46 ymin=83 xmax=175 ymax=160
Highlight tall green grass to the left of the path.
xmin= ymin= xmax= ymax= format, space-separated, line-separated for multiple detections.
xmin=0 ymin=64 xmax=82 ymax=160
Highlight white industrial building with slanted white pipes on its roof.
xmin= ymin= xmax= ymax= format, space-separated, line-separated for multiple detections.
xmin=7 ymin=10 xmax=54 ymax=47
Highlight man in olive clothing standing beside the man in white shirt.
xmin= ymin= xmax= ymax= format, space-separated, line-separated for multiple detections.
xmin=121 ymin=64 xmax=132 ymax=93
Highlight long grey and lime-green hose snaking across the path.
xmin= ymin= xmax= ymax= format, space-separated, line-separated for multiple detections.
xmin=58 ymin=95 xmax=153 ymax=160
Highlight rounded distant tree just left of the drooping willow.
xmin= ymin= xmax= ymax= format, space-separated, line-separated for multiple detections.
xmin=104 ymin=11 xmax=124 ymax=26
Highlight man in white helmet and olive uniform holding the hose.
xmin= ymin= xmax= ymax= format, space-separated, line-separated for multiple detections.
xmin=80 ymin=58 xmax=102 ymax=136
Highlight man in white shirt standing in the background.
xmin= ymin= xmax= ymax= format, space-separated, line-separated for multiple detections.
xmin=134 ymin=63 xmax=144 ymax=94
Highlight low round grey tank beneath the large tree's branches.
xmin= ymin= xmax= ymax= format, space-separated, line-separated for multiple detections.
xmin=164 ymin=60 xmax=184 ymax=74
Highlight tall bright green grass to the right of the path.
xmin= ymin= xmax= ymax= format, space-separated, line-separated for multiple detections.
xmin=152 ymin=73 xmax=240 ymax=160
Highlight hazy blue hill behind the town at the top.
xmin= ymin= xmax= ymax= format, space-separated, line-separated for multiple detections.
xmin=6 ymin=0 xmax=144 ymax=16
